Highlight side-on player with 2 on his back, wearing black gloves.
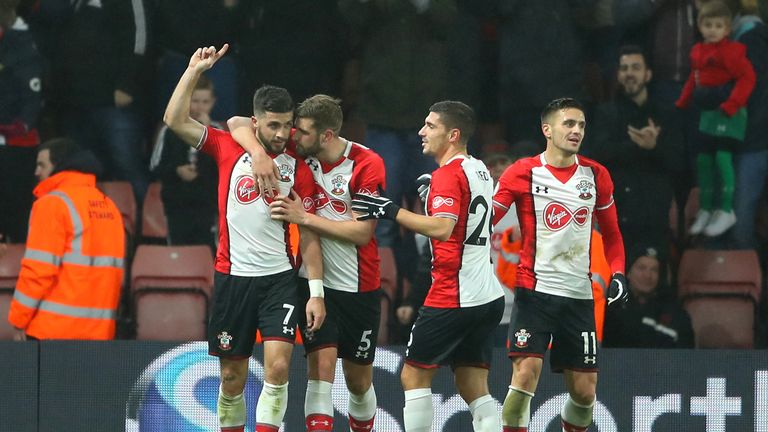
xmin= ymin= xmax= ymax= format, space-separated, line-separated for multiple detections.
xmin=352 ymin=101 xmax=504 ymax=432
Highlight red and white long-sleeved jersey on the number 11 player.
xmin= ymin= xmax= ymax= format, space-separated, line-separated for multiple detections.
xmin=493 ymin=153 xmax=624 ymax=299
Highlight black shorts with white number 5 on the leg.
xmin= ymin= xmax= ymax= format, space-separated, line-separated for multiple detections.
xmin=299 ymin=278 xmax=381 ymax=365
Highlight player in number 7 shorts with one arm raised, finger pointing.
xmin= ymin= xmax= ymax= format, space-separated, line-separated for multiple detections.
xmin=163 ymin=44 xmax=325 ymax=432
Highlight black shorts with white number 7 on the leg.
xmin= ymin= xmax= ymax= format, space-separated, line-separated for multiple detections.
xmin=208 ymin=270 xmax=303 ymax=359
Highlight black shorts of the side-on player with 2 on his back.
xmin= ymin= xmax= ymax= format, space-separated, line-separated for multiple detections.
xmin=405 ymin=297 xmax=504 ymax=369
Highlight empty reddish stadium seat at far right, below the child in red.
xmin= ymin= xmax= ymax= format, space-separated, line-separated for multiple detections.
xmin=678 ymin=249 xmax=762 ymax=348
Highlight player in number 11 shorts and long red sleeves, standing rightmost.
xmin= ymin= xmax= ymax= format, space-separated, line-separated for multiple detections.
xmin=493 ymin=99 xmax=628 ymax=432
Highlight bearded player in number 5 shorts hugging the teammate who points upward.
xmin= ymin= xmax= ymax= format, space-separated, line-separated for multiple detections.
xmin=229 ymin=95 xmax=384 ymax=432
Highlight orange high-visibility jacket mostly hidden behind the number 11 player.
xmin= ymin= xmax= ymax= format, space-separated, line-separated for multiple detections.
xmin=496 ymin=228 xmax=611 ymax=342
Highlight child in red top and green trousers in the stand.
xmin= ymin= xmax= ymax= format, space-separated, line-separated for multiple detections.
xmin=675 ymin=0 xmax=755 ymax=237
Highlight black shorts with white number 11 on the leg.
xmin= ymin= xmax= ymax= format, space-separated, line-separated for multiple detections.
xmin=508 ymin=288 xmax=598 ymax=372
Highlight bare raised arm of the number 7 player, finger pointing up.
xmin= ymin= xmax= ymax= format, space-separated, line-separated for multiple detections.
xmin=163 ymin=44 xmax=229 ymax=147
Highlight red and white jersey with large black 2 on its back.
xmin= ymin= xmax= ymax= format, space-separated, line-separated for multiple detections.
xmin=424 ymin=155 xmax=504 ymax=308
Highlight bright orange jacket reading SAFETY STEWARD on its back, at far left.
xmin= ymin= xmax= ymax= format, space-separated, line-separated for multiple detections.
xmin=8 ymin=171 xmax=125 ymax=339
